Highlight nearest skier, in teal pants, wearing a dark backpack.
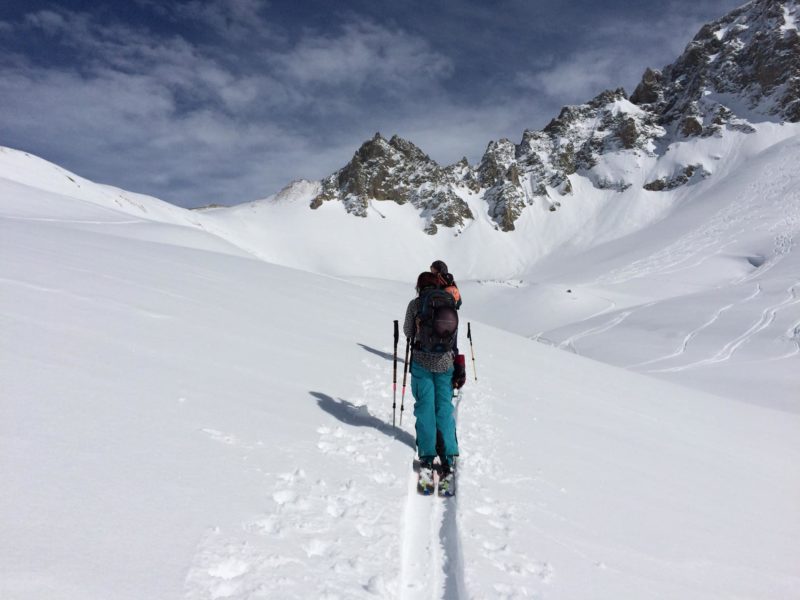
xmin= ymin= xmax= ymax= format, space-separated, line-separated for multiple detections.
xmin=403 ymin=272 xmax=458 ymax=496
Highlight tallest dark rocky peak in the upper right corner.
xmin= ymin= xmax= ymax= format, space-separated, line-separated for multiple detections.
xmin=631 ymin=0 xmax=800 ymax=129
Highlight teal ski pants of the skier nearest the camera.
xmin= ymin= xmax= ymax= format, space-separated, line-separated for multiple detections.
xmin=411 ymin=361 xmax=458 ymax=460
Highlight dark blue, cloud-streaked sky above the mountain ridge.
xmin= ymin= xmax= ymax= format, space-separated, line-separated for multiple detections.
xmin=0 ymin=0 xmax=742 ymax=206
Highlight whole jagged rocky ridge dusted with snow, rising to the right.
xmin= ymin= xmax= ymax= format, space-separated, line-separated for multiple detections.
xmin=311 ymin=0 xmax=800 ymax=234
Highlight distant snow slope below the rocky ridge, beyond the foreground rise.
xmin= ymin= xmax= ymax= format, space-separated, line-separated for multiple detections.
xmin=203 ymin=122 xmax=800 ymax=412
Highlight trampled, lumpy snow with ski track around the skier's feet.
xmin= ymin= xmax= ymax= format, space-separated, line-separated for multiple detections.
xmin=184 ymin=352 xmax=554 ymax=600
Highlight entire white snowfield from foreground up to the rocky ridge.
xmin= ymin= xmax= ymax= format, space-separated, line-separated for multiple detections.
xmin=0 ymin=123 xmax=800 ymax=600
